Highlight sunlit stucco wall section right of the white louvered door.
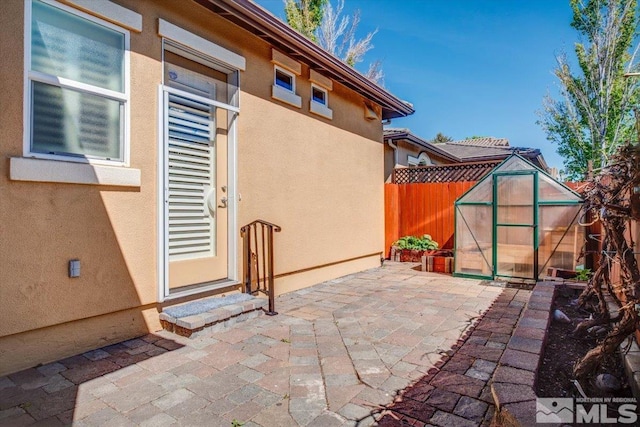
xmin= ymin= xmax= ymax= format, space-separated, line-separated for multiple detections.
xmin=239 ymin=93 xmax=384 ymax=292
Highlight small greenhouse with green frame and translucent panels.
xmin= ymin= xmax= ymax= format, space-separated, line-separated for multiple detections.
xmin=454 ymin=154 xmax=584 ymax=279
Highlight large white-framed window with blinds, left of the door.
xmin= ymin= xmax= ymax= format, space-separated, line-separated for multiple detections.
xmin=24 ymin=0 xmax=130 ymax=165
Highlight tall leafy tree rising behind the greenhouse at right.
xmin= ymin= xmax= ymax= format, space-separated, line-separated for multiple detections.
xmin=538 ymin=0 xmax=639 ymax=179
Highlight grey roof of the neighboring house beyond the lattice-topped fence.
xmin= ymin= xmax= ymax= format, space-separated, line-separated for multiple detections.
xmin=384 ymin=129 xmax=549 ymax=170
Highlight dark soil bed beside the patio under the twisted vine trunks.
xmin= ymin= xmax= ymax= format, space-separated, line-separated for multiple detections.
xmin=536 ymin=288 xmax=633 ymax=425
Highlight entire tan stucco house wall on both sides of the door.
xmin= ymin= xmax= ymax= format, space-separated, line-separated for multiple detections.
xmin=0 ymin=0 xmax=384 ymax=374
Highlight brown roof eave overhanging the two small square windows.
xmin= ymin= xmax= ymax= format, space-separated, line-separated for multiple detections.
xmin=193 ymin=0 xmax=415 ymax=119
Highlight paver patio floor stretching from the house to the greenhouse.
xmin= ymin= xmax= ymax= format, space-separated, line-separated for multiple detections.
xmin=0 ymin=262 xmax=528 ymax=427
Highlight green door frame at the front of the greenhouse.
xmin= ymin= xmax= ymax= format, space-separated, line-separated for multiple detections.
xmin=492 ymin=170 xmax=539 ymax=280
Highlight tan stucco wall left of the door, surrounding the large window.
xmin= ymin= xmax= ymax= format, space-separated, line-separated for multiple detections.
xmin=0 ymin=0 xmax=160 ymax=336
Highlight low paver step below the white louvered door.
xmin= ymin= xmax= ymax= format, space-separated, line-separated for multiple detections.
xmin=159 ymin=298 xmax=269 ymax=338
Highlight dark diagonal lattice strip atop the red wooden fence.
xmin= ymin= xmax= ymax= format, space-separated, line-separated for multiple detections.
xmin=393 ymin=160 xmax=501 ymax=184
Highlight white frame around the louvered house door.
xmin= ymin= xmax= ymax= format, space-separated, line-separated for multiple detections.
xmin=157 ymin=83 xmax=240 ymax=302
